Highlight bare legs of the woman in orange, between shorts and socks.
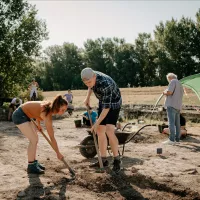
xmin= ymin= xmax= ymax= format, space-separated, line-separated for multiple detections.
xmin=17 ymin=122 xmax=38 ymax=162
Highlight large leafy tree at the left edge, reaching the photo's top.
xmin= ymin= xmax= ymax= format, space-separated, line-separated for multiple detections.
xmin=0 ymin=0 xmax=47 ymax=95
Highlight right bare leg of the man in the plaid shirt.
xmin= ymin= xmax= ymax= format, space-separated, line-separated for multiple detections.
xmin=106 ymin=124 xmax=119 ymax=157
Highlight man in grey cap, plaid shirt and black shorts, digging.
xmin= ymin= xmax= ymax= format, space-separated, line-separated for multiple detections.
xmin=81 ymin=68 xmax=122 ymax=173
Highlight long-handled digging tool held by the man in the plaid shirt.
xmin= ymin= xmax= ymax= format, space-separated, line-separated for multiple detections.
xmin=87 ymin=106 xmax=105 ymax=173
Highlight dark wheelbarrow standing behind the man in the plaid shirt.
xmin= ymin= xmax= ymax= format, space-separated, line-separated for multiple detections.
xmin=78 ymin=123 xmax=157 ymax=158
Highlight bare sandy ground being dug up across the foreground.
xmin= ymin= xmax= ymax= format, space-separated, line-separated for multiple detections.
xmin=0 ymin=113 xmax=200 ymax=200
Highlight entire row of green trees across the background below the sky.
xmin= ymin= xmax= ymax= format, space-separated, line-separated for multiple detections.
xmin=0 ymin=0 xmax=200 ymax=93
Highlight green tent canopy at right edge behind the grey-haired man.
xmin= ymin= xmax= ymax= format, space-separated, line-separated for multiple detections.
xmin=180 ymin=74 xmax=200 ymax=100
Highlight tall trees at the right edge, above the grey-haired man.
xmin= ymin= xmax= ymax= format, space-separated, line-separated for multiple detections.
xmin=154 ymin=13 xmax=200 ymax=84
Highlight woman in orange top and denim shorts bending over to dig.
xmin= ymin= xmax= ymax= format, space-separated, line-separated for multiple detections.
xmin=12 ymin=95 xmax=68 ymax=174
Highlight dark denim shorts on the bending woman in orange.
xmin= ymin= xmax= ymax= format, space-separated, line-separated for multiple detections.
xmin=12 ymin=107 xmax=31 ymax=125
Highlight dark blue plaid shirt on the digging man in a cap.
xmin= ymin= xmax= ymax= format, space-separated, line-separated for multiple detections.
xmin=92 ymin=71 xmax=122 ymax=109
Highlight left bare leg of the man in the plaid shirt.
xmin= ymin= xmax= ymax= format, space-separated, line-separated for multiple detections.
xmin=97 ymin=125 xmax=108 ymax=157
